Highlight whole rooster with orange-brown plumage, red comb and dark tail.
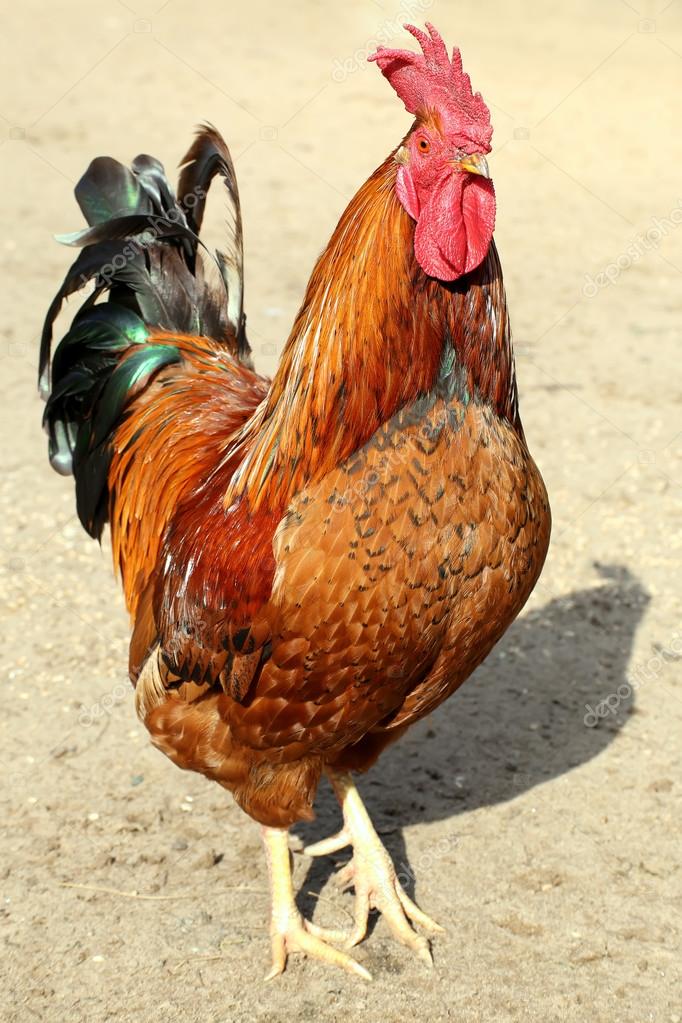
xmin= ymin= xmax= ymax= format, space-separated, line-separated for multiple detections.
xmin=41 ymin=25 xmax=550 ymax=978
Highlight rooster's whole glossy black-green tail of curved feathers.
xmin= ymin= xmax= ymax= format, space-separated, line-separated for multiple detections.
xmin=40 ymin=126 xmax=251 ymax=536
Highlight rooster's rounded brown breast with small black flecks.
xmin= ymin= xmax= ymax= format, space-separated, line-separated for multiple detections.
xmin=232 ymin=400 xmax=549 ymax=758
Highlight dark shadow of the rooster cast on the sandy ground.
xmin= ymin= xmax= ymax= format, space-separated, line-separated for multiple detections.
xmin=294 ymin=565 xmax=650 ymax=926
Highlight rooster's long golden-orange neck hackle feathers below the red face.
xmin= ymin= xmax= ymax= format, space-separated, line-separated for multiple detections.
xmin=233 ymin=157 xmax=520 ymax=507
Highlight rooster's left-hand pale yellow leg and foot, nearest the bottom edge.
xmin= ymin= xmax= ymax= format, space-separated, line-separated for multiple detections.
xmin=263 ymin=828 xmax=372 ymax=980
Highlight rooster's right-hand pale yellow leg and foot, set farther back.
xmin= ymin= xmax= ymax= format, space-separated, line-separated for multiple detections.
xmin=305 ymin=770 xmax=445 ymax=966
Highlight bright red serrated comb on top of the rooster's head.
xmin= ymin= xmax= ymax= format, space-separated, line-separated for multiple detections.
xmin=369 ymin=21 xmax=493 ymax=152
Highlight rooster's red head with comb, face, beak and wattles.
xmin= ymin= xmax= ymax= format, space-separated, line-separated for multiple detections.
xmin=369 ymin=23 xmax=495 ymax=280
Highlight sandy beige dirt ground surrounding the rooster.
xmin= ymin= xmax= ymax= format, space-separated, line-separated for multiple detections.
xmin=0 ymin=0 xmax=682 ymax=1023
